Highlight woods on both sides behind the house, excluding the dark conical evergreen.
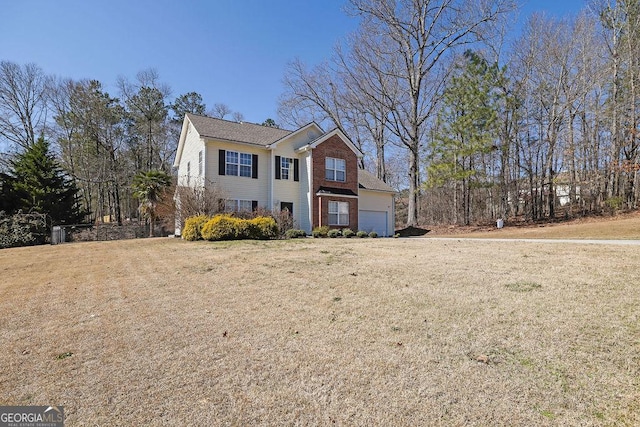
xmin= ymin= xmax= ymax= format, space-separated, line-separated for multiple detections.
xmin=0 ymin=0 xmax=640 ymax=231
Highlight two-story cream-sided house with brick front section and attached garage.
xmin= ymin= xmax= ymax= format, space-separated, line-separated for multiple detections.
xmin=174 ymin=114 xmax=395 ymax=236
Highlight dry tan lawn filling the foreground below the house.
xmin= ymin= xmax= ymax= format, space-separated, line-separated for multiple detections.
xmin=0 ymin=238 xmax=640 ymax=426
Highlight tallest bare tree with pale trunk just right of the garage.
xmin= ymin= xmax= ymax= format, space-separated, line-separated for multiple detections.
xmin=350 ymin=0 xmax=515 ymax=225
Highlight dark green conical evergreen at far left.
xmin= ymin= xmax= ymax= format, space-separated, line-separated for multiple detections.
xmin=5 ymin=136 xmax=83 ymax=224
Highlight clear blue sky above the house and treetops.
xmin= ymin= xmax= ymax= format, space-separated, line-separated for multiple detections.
xmin=0 ymin=0 xmax=585 ymax=123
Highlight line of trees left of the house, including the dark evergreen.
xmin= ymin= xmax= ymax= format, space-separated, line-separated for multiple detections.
xmin=0 ymin=61 xmax=264 ymax=230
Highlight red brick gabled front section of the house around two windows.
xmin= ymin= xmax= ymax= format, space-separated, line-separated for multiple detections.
xmin=312 ymin=135 xmax=358 ymax=231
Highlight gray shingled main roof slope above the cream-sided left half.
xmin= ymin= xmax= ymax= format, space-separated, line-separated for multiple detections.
xmin=187 ymin=113 xmax=291 ymax=146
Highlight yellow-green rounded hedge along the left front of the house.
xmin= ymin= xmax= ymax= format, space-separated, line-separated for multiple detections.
xmin=182 ymin=214 xmax=278 ymax=241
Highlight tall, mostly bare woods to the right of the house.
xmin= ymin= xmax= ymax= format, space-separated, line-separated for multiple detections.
xmin=280 ymin=0 xmax=640 ymax=225
